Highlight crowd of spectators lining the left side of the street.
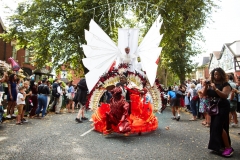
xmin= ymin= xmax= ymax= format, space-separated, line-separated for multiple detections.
xmin=0 ymin=73 xmax=88 ymax=125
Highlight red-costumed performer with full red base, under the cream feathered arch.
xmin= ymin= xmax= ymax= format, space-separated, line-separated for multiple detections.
xmin=92 ymin=76 xmax=158 ymax=135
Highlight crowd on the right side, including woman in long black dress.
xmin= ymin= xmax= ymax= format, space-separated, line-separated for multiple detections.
xmin=167 ymin=68 xmax=240 ymax=157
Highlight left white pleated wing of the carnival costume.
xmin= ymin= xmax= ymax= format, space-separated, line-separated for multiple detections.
xmin=83 ymin=20 xmax=121 ymax=92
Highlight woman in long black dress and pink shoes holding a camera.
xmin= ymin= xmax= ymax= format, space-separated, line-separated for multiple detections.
xmin=203 ymin=68 xmax=233 ymax=157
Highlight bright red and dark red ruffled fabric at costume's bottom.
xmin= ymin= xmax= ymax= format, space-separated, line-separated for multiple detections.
xmin=92 ymin=89 xmax=158 ymax=133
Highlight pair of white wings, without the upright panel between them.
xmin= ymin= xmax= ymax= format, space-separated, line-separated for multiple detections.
xmin=83 ymin=16 xmax=162 ymax=92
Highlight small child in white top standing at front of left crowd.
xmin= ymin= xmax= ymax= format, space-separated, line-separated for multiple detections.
xmin=16 ymin=86 xmax=26 ymax=125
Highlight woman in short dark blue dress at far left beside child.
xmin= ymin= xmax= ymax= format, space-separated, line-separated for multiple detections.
xmin=6 ymin=74 xmax=17 ymax=118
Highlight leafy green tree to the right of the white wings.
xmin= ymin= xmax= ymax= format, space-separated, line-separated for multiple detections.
xmin=158 ymin=0 xmax=216 ymax=82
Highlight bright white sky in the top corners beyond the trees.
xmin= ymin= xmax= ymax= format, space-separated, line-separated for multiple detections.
xmin=0 ymin=0 xmax=240 ymax=57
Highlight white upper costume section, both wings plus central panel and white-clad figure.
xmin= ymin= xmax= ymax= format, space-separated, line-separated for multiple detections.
xmin=83 ymin=16 xmax=162 ymax=92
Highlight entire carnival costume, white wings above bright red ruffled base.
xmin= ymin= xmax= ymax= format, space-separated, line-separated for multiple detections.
xmin=82 ymin=16 xmax=162 ymax=134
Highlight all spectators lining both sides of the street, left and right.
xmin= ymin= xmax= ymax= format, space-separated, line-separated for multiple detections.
xmin=0 ymin=68 xmax=240 ymax=157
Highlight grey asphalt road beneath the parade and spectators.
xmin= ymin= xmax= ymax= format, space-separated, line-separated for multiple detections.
xmin=0 ymin=108 xmax=240 ymax=160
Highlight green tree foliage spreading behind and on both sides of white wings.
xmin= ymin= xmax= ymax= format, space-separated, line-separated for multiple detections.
xmin=2 ymin=0 xmax=218 ymax=80
